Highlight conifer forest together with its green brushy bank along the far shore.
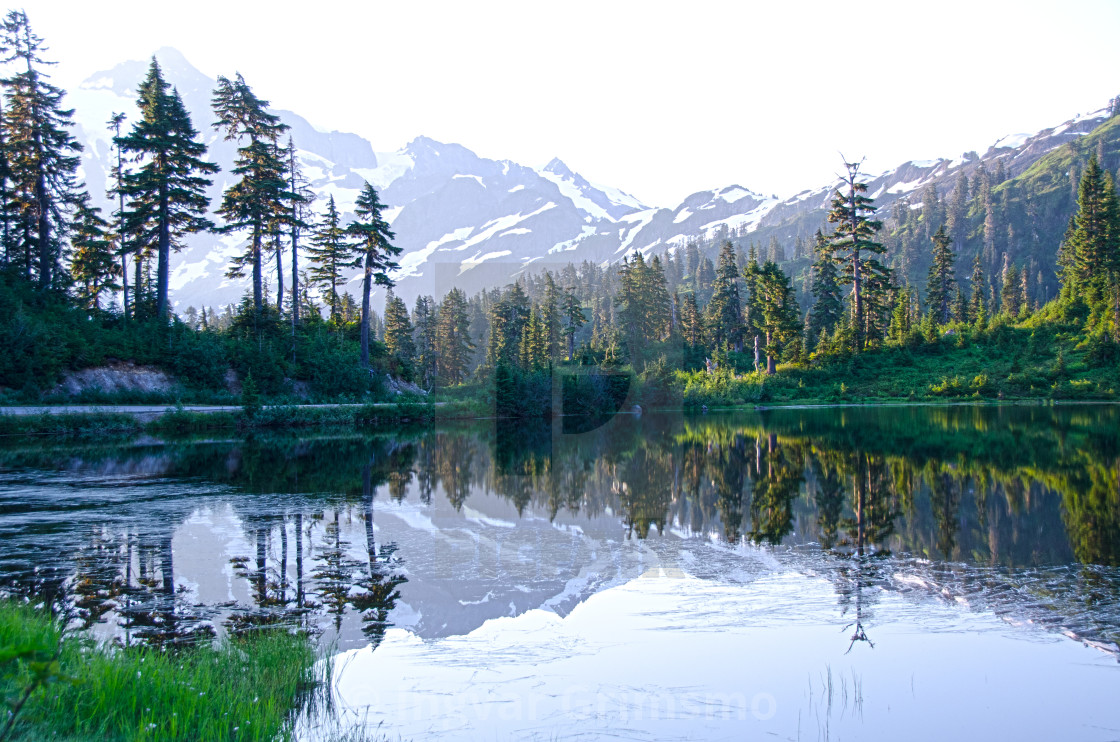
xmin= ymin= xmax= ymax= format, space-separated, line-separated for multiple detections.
xmin=0 ymin=11 xmax=1120 ymax=416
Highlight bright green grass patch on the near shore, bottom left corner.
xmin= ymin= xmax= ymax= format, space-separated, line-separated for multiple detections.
xmin=0 ymin=601 xmax=321 ymax=742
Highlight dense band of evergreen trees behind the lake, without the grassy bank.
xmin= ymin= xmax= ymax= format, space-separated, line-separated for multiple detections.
xmin=0 ymin=12 xmax=1120 ymax=410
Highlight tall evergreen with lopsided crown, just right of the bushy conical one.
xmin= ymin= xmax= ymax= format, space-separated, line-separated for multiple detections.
xmin=212 ymin=74 xmax=292 ymax=318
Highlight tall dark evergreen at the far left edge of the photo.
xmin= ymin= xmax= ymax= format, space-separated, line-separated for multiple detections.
xmin=0 ymin=10 xmax=82 ymax=290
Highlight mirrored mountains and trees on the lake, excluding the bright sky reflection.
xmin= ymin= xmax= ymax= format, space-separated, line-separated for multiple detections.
xmin=0 ymin=407 xmax=1120 ymax=643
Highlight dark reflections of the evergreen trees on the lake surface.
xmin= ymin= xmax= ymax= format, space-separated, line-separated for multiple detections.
xmin=0 ymin=409 xmax=1120 ymax=659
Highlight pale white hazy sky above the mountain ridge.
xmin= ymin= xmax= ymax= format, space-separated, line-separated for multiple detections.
xmin=15 ymin=0 xmax=1120 ymax=206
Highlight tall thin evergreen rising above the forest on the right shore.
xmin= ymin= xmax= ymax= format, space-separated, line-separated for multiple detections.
xmin=829 ymin=163 xmax=890 ymax=352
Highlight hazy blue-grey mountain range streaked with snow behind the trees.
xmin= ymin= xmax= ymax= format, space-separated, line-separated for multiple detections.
xmin=67 ymin=48 xmax=1108 ymax=309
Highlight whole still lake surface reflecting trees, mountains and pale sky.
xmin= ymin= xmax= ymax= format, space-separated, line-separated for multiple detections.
xmin=0 ymin=406 xmax=1120 ymax=740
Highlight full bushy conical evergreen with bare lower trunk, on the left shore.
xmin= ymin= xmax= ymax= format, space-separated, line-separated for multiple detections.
xmin=116 ymin=57 xmax=218 ymax=321
